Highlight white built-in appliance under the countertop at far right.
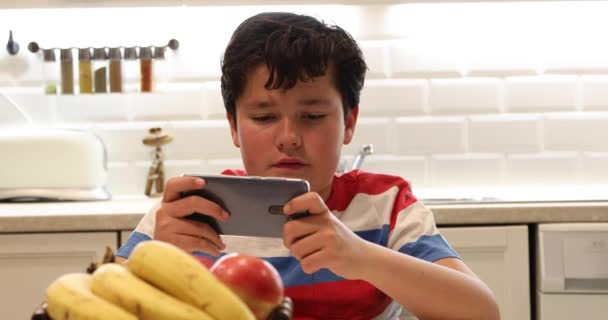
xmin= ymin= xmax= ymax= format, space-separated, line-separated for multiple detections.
xmin=536 ymin=223 xmax=608 ymax=320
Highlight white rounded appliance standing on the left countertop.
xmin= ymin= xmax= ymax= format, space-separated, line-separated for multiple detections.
xmin=0 ymin=128 xmax=111 ymax=202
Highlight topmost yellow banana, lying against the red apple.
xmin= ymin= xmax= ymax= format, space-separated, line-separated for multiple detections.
xmin=127 ymin=240 xmax=255 ymax=320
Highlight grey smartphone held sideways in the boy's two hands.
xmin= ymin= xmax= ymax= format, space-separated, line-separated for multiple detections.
xmin=181 ymin=174 xmax=310 ymax=238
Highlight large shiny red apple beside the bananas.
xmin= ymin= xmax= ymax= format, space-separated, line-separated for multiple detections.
xmin=210 ymin=253 xmax=284 ymax=320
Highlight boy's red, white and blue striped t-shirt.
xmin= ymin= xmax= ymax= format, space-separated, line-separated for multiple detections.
xmin=117 ymin=170 xmax=458 ymax=320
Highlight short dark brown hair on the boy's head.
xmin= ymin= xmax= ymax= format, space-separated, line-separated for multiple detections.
xmin=221 ymin=12 xmax=367 ymax=121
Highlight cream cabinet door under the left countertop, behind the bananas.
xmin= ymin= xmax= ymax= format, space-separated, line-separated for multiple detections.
xmin=0 ymin=232 xmax=117 ymax=319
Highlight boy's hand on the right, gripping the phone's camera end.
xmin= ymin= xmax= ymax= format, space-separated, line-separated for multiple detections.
xmin=283 ymin=192 xmax=366 ymax=279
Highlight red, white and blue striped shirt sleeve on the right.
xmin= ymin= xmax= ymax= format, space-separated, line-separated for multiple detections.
xmin=388 ymin=183 xmax=459 ymax=262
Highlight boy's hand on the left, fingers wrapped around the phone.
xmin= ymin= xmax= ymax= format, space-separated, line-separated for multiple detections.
xmin=154 ymin=177 xmax=228 ymax=256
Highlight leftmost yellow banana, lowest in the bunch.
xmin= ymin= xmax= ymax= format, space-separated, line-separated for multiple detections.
xmin=46 ymin=273 xmax=137 ymax=320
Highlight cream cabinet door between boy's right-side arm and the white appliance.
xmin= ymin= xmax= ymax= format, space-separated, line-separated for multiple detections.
xmin=439 ymin=226 xmax=530 ymax=320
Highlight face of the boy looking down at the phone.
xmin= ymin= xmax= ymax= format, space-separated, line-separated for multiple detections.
xmin=228 ymin=65 xmax=358 ymax=199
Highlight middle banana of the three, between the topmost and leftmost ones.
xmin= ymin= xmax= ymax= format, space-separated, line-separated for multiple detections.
xmin=91 ymin=263 xmax=213 ymax=320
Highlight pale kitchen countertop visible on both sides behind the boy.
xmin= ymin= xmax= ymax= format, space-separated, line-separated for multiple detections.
xmin=0 ymin=198 xmax=608 ymax=233
